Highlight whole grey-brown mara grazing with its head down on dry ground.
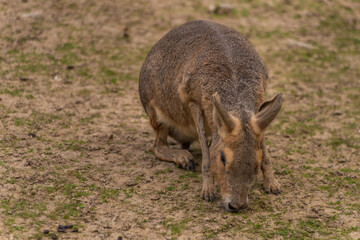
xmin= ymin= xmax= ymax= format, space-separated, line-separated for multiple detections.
xmin=139 ymin=21 xmax=282 ymax=212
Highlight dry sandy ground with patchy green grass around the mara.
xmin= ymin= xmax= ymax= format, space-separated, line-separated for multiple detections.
xmin=0 ymin=0 xmax=360 ymax=239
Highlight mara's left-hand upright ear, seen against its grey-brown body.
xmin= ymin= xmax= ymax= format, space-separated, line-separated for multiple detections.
xmin=213 ymin=93 xmax=235 ymax=133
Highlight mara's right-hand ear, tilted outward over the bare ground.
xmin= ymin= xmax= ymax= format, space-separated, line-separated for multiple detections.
xmin=255 ymin=93 xmax=283 ymax=131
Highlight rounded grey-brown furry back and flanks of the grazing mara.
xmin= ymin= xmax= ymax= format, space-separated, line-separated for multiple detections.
xmin=139 ymin=21 xmax=268 ymax=136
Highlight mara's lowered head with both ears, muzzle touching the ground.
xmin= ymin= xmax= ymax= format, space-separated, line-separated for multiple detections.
xmin=211 ymin=94 xmax=282 ymax=212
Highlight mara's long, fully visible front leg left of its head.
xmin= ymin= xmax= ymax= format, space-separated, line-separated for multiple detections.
xmin=189 ymin=102 xmax=216 ymax=201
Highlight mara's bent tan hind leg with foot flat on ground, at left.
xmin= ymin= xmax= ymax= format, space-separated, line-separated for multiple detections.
xmin=148 ymin=105 xmax=195 ymax=170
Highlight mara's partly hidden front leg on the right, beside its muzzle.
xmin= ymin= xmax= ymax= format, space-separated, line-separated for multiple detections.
xmin=261 ymin=137 xmax=281 ymax=195
